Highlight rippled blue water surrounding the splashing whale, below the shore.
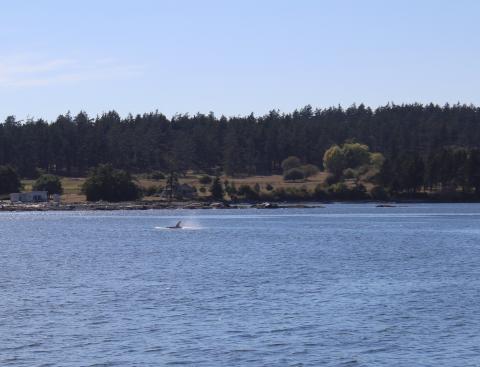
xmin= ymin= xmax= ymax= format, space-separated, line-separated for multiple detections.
xmin=0 ymin=204 xmax=480 ymax=367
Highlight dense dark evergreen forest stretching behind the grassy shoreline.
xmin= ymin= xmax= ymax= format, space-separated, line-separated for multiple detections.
xmin=0 ymin=104 xmax=480 ymax=196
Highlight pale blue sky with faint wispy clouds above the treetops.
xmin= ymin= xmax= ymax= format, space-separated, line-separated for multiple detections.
xmin=0 ymin=0 xmax=480 ymax=120
